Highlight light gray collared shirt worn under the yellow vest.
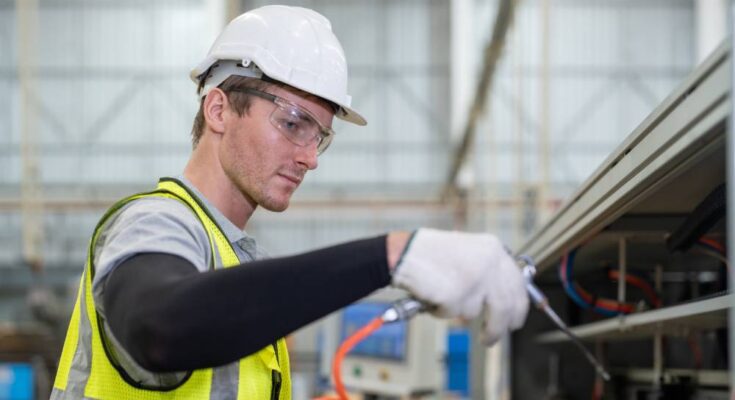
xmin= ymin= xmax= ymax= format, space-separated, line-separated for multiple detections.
xmin=92 ymin=177 xmax=267 ymax=386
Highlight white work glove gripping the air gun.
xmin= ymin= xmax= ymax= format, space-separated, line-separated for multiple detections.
xmin=393 ymin=228 xmax=528 ymax=346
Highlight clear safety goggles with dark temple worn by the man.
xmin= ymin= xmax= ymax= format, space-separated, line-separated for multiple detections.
xmin=228 ymin=88 xmax=334 ymax=155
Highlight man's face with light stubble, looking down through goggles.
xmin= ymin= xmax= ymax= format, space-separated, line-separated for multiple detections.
xmin=220 ymin=86 xmax=334 ymax=211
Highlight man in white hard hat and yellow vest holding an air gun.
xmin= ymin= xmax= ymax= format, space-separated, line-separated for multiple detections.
xmin=52 ymin=6 xmax=528 ymax=399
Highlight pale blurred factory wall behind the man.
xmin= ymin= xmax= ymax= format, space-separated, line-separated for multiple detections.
xmin=0 ymin=0 xmax=695 ymax=396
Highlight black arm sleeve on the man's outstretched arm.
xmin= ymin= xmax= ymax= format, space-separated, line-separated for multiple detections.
xmin=103 ymin=236 xmax=390 ymax=372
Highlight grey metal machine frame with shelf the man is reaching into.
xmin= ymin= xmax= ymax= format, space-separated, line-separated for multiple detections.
xmin=516 ymin=42 xmax=735 ymax=398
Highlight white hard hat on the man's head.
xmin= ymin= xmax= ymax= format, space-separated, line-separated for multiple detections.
xmin=190 ymin=6 xmax=366 ymax=125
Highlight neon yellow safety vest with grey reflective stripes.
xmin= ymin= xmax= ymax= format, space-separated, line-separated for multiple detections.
xmin=51 ymin=178 xmax=291 ymax=400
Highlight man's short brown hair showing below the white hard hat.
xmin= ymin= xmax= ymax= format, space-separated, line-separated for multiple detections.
xmin=191 ymin=75 xmax=287 ymax=148
